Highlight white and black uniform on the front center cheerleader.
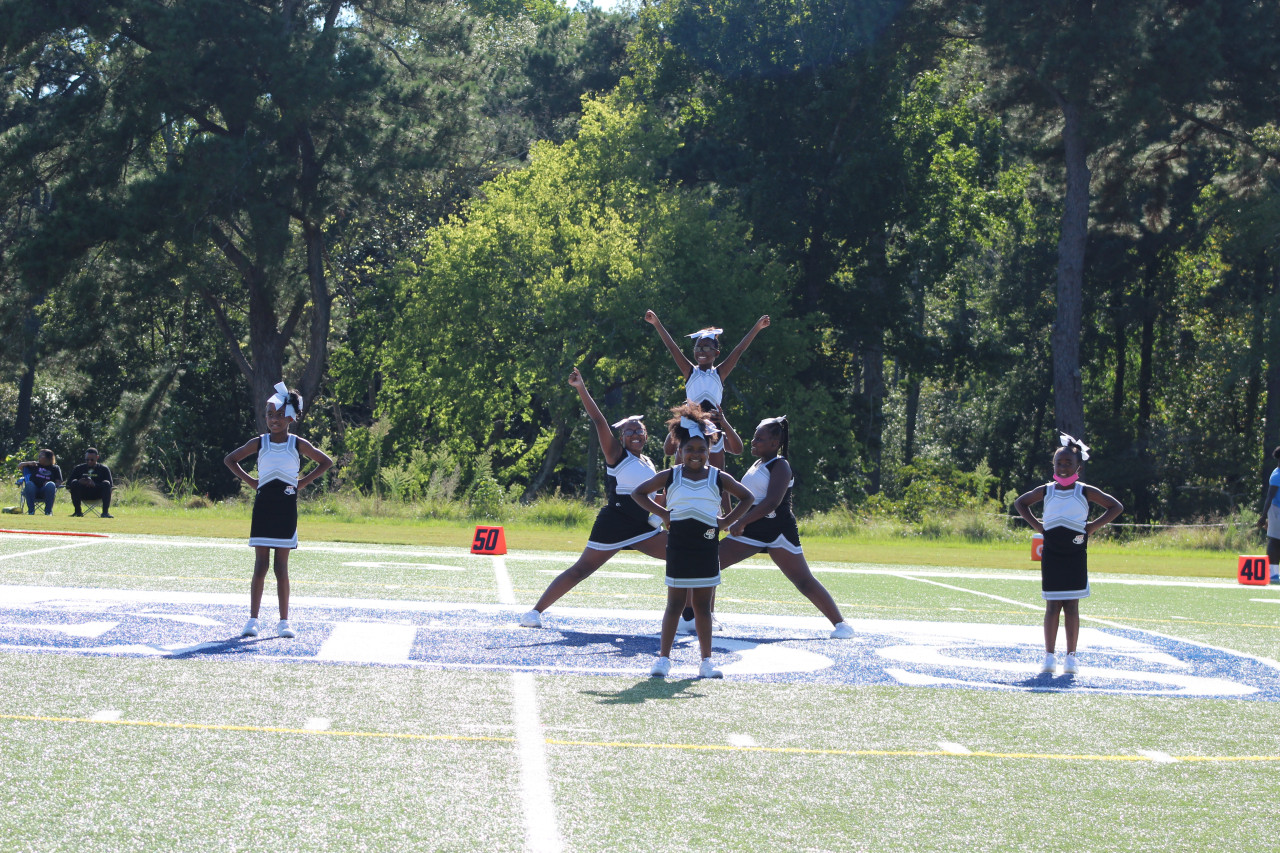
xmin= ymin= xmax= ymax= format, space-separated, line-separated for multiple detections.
xmin=667 ymin=465 xmax=721 ymax=588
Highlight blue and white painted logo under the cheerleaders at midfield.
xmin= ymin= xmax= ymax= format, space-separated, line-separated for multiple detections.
xmin=0 ymin=587 xmax=1280 ymax=701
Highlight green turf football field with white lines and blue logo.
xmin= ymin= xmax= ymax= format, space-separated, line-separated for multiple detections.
xmin=0 ymin=530 xmax=1280 ymax=852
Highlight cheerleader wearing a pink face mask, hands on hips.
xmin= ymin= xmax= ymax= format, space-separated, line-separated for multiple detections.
xmin=1014 ymin=433 xmax=1124 ymax=675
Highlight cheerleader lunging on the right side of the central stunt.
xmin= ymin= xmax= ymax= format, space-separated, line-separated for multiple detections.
xmin=719 ymin=415 xmax=854 ymax=639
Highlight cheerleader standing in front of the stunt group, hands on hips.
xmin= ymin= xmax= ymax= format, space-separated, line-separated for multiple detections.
xmin=631 ymin=403 xmax=751 ymax=679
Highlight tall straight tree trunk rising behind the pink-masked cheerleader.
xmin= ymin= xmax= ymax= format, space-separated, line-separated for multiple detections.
xmin=1052 ymin=100 xmax=1089 ymax=441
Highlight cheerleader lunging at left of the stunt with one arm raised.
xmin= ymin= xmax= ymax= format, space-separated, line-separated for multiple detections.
xmin=520 ymin=369 xmax=667 ymax=628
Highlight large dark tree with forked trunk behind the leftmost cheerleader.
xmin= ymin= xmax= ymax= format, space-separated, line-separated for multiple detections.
xmin=0 ymin=0 xmax=474 ymax=420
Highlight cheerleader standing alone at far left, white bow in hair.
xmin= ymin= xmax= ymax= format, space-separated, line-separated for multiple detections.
xmin=223 ymin=382 xmax=333 ymax=637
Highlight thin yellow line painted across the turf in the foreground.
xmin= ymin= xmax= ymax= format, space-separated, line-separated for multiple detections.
xmin=0 ymin=713 xmax=1280 ymax=763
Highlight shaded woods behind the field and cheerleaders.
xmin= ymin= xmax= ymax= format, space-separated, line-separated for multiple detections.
xmin=0 ymin=0 xmax=1280 ymax=520
